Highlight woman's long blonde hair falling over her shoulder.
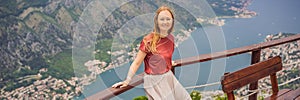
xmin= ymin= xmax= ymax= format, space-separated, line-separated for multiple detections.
xmin=143 ymin=6 xmax=174 ymax=53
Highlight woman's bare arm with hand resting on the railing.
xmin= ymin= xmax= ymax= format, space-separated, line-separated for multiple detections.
xmin=112 ymin=50 xmax=147 ymax=88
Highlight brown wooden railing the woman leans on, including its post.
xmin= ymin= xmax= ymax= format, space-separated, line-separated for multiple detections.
xmin=86 ymin=34 xmax=300 ymax=100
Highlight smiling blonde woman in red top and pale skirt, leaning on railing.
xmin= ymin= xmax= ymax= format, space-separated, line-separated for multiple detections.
xmin=112 ymin=6 xmax=191 ymax=100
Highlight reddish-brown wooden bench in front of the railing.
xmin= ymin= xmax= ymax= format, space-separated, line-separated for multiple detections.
xmin=221 ymin=56 xmax=282 ymax=100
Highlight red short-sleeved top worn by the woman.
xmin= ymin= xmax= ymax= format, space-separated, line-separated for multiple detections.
xmin=139 ymin=34 xmax=174 ymax=74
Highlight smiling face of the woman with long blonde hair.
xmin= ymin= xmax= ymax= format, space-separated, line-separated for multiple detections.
xmin=157 ymin=10 xmax=173 ymax=32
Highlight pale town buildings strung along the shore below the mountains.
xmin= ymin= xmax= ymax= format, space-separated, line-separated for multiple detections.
xmin=0 ymin=0 xmax=256 ymax=99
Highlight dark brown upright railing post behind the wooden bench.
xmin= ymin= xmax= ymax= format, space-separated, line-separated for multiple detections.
xmin=249 ymin=49 xmax=261 ymax=100
